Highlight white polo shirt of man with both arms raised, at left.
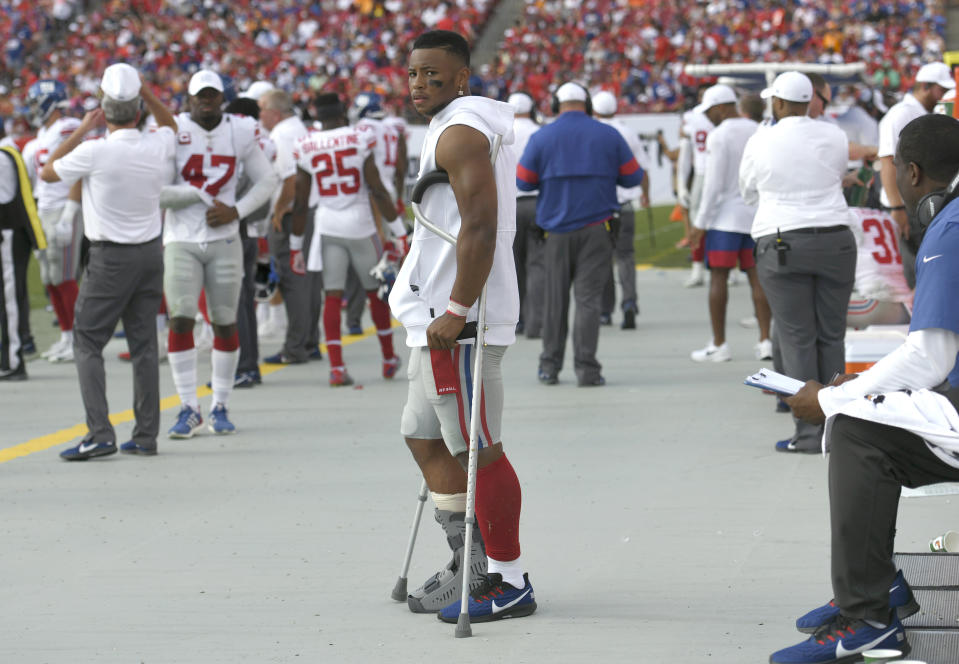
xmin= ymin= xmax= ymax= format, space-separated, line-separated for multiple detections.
xmin=53 ymin=127 xmax=176 ymax=244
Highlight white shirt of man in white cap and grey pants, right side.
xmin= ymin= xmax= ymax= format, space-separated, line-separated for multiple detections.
xmin=739 ymin=115 xmax=849 ymax=239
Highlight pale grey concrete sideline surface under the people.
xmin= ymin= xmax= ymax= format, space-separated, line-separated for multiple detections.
xmin=0 ymin=270 xmax=956 ymax=664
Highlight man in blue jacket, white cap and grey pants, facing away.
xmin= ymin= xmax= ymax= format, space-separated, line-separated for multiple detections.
xmin=516 ymin=82 xmax=643 ymax=387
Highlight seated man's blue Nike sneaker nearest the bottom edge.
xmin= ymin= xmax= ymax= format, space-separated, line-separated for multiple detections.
xmin=769 ymin=611 xmax=911 ymax=664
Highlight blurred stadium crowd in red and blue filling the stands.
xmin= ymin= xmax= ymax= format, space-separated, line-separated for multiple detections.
xmin=0 ymin=0 xmax=944 ymax=134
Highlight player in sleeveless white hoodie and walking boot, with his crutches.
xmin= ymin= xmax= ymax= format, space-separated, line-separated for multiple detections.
xmin=390 ymin=31 xmax=536 ymax=636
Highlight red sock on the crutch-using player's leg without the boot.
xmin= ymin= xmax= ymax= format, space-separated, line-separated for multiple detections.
xmin=476 ymin=454 xmax=523 ymax=562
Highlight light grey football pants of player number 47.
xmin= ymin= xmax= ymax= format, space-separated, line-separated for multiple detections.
xmin=163 ymin=235 xmax=243 ymax=325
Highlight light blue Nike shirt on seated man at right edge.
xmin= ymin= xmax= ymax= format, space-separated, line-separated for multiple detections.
xmin=909 ymin=199 xmax=959 ymax=387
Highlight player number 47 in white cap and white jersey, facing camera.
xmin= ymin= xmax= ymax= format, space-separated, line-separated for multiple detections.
xmin=160 ymin=70 xmax=279 ymax=438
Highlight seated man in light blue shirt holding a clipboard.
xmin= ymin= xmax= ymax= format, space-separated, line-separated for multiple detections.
xmin=769 ymin=114 xmax=959 ymax=662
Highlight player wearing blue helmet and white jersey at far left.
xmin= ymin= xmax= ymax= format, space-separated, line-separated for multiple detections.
xmin=23 ymin=79 xmax=83 ymax=362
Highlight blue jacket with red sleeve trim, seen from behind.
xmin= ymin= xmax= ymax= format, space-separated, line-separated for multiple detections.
xmin=516 ymin=111 xmax=643 ymax=233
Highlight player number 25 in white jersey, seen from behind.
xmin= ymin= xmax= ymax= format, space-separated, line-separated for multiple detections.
xmin=293 ymin=94 xmax=399 ymax=387
